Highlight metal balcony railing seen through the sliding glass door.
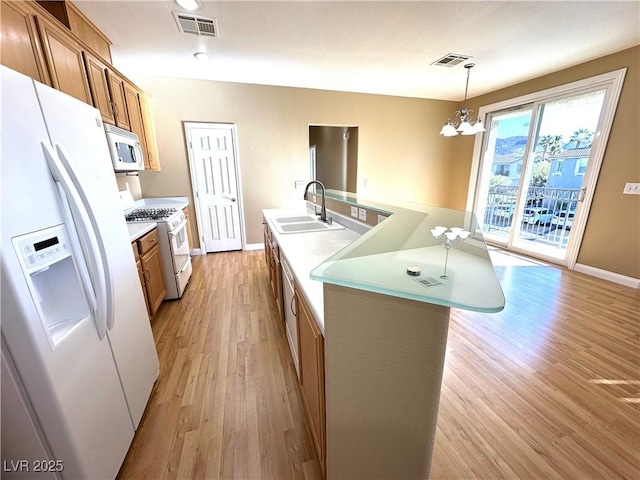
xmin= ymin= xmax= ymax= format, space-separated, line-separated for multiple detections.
xmin=483 ymin=186 xmax=582 ymax=248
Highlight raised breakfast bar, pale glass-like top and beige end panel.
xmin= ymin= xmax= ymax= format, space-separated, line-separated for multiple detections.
xmin=262 ymin=191 xmax=505 ymax=479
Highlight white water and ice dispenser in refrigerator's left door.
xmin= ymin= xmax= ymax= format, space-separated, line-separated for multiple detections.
xmin=12 ymin=225 xmax=91 ymax=350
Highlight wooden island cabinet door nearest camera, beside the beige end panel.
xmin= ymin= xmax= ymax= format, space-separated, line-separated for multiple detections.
xmin=296 ymin=289 xmax=326 ymax=473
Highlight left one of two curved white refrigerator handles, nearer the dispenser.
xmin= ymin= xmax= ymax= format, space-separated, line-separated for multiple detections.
xmin=42 ymin=142 xmax=107 ymax=340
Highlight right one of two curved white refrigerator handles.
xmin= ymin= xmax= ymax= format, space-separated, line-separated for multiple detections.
xmin=56 ymin=144 xmax=114 ymax=330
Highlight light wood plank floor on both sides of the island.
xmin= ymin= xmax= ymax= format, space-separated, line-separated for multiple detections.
xmin=119 ymin=251 xmax=640 ymax=480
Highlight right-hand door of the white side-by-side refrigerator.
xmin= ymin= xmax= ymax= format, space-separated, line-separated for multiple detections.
xmin=36 ymin=77 xmax=159 ymax=428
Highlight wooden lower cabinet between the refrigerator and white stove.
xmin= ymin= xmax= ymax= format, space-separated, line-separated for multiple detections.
xmin=132 ymin=229 xmax=167 ymax=317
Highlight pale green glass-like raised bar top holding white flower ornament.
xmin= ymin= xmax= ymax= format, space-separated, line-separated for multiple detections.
xmin=311 ymin=190 xmax=505 ymax=312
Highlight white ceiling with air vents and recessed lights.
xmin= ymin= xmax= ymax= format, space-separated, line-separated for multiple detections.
xmin=74 ymin=0 xmax=640 ymax=101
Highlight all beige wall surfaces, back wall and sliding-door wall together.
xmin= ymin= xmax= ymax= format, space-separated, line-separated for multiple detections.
xmin=134 ymin=47 xmax=640 ymax=278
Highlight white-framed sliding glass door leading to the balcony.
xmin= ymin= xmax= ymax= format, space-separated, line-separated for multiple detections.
xmin=473 ymin=70 xmax=617 ymax=266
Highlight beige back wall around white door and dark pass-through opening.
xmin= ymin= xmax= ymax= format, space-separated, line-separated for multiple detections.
xmin=133 ymin=77 xmax=455 ymax=246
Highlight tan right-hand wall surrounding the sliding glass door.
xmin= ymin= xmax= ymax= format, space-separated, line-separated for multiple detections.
xmin=450 ymin=46 xmax=640 ymax=278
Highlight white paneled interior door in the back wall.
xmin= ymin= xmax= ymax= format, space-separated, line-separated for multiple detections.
xmin=185 ymin=123 xmax=242 ymax=253
